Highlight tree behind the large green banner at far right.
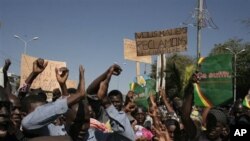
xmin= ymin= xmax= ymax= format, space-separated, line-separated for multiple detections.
xmin=209 ymin=38 xmax=250 ymax=98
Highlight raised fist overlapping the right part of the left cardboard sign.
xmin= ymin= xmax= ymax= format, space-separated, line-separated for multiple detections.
xmin=55 ymin=67 xmax=69 ymax=84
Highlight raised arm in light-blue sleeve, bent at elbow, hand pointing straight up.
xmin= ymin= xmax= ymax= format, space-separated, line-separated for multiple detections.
xmin=22 ymin=66 xmax=85 ymax=130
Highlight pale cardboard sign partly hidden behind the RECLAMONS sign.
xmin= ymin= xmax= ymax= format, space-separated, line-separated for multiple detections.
xmin=123 ymin=39 xmax=152 ymax=64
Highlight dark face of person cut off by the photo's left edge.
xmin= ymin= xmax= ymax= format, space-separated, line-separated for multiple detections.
xmin=0 ymin=101 xmax=11 ymax=138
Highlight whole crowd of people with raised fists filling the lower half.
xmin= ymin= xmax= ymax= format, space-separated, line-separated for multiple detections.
xmin=0 ymin=58 xmax=250 ymax=141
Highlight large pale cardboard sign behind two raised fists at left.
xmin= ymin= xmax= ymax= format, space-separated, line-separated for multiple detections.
xmin=20 ymin=54 xmax=66 ymax=91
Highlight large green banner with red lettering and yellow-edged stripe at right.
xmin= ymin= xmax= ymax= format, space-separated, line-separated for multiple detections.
xmin=194 ymin=54 xmax=233 ymax=107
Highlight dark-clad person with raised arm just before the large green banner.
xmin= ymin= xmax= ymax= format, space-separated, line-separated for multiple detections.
xmin=181 ymin=74 xmax=229 ymax=141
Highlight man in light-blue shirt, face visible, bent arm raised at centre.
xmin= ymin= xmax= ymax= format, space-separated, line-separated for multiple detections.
xmin=88 ymin=65 xmax=135 ymax=141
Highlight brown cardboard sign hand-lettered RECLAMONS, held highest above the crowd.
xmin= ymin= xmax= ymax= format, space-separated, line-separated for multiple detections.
xmin=135 ymin=27 xmax=188 ymax=56
